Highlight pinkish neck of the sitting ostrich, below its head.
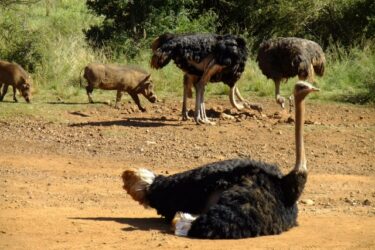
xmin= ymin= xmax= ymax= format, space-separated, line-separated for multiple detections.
xmin=294 ymin=98 xmax=307 ymax=173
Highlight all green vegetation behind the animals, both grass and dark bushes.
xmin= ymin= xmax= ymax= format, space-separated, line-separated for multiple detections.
xmin=0 ymin=0 xmax=375 ymax=104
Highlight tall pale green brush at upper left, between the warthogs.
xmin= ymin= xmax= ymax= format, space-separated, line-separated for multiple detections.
xmin=0 ymin=0 xmax=100 ymax=96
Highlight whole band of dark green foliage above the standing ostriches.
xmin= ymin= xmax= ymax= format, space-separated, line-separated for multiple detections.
xmin=86 ymin=0 xmax=375 ymax=51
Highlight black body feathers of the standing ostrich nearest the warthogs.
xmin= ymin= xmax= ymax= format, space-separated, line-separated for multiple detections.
xmin=151 ymin=33 xmax=247 ymax=87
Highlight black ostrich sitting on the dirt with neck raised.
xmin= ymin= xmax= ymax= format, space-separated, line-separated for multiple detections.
xmin=122 ymin=81 xmax=319 ymax=238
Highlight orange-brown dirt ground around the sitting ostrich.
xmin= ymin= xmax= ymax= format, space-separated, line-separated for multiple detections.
xmin=0 ymin=99 xmax=375 ymax=250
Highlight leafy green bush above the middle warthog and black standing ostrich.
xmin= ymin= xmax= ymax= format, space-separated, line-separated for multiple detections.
xmin=86 ymin=0 xmax=215 ymax=58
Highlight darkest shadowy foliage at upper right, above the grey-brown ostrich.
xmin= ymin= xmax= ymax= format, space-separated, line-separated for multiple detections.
xmin=195 ymin=0 xmax=375 ymax=50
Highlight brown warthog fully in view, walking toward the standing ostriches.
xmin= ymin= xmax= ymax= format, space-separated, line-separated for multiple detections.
xmin=83 ymin=63 xmax=157 ymax=112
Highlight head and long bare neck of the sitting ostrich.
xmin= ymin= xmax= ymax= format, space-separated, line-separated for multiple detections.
xmin=294 ymin=81 xmax=319 ymax=173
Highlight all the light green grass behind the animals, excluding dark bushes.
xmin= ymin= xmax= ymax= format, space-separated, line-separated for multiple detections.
xmin=0 ymin=0 xmax=375 ymax=110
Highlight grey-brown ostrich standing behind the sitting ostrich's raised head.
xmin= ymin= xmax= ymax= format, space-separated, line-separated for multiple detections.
xmin=257 ymin=37 xmax=326 ymax=108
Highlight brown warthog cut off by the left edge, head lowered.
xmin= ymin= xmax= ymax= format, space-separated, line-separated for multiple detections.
xmin=0 ymin=60 xmax=31 ymax=102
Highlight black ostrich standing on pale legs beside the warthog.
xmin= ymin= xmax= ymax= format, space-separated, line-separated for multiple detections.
xmin=151 ymin=33 xmax=262 ymax=124
